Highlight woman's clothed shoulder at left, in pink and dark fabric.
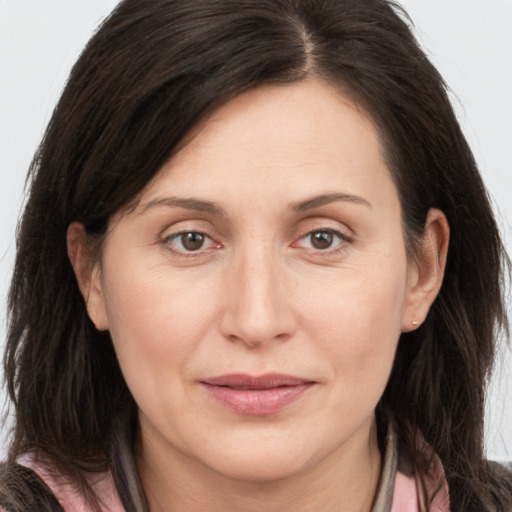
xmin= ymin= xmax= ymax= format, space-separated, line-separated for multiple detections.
xmin=0 ymin=455 xmax=124 ymax=512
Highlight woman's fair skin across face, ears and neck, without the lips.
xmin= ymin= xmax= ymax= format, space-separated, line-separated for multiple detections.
xmin=68 ymin=80 xmax=448 ymax=512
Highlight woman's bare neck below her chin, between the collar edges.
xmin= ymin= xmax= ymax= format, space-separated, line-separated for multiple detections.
xmin=137 ymin=419 xmax=381 ymax=512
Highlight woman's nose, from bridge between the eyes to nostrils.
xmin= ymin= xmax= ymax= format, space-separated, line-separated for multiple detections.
xmin=221 ymin=244 xmax=296 ymax=348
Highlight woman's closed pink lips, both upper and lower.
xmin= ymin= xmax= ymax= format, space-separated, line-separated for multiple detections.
xmin=201 ymin=373 xmax=315 ymax=416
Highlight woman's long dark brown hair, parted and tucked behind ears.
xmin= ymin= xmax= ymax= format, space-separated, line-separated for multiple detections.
xmin=4 ymin=0 xmax=512 ymax=511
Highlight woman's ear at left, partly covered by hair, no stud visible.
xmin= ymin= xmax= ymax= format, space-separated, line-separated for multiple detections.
xmin=67 ymin=222 xmax=109 ymax=331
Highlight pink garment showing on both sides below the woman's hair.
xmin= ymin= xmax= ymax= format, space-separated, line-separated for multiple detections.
xmin=14 ymin=456 xmax=450 ymax=512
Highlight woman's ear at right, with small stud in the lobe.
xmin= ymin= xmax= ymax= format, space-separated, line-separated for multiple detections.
xmin=402 ymin=208 xmax=450 ymax=332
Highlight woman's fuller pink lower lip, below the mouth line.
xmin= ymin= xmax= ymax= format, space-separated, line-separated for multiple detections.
xmin=202 ymin=383 xmax=313 ymax=416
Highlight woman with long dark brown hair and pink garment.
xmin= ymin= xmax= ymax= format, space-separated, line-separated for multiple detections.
xmin=0 ymin=0 xmax=512 ymax=512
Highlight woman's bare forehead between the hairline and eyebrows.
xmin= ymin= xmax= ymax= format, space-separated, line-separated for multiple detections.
xmin=134 ymin=80 xmax=396 ymax=216
